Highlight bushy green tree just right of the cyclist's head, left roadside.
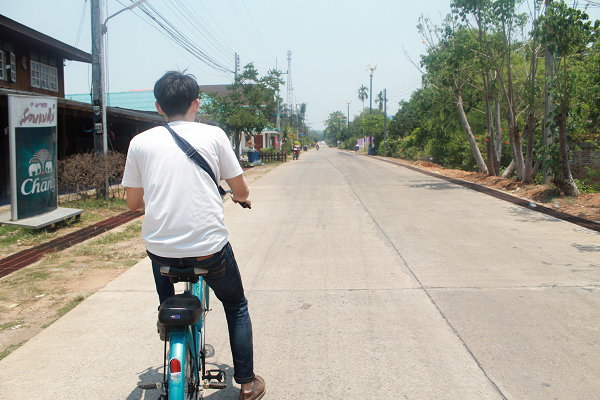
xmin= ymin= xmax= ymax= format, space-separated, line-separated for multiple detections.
xmin=197 ymin=63 xmax=283 ymax=157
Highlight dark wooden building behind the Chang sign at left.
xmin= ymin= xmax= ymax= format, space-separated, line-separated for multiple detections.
xmin=0 ymin=15 xmax=163 ymax=204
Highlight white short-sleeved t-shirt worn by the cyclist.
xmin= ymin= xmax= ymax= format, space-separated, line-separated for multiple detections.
xmin=122 ymin=121 xmax=242 ymax=258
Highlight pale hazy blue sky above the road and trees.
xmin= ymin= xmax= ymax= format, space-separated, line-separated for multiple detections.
xmin=0 ymin=0 xmax=600 ymax=130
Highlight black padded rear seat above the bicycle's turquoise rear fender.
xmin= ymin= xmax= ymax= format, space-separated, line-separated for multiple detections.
xmin=158 ymin=293 xmax=204 ymax=326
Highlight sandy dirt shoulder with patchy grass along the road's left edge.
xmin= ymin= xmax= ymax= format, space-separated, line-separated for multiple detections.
xmin=0 ymin=163 xmax=279 ymax=359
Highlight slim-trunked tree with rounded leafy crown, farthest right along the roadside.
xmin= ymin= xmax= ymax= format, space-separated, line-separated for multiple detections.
xmin=539 ymin=1 xmax=600 ymax=196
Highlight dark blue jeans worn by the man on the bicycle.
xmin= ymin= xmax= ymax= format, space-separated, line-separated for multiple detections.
xmin=148 ymin=243 xmax=254 ymax=384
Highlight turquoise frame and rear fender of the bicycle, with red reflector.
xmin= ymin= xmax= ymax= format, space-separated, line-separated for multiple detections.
xmin=164 ymin=277 xmax=209 ymax=400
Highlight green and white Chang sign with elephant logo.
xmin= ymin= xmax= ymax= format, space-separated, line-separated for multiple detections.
xmin=8 ymin=95 xmax=58 ymax=221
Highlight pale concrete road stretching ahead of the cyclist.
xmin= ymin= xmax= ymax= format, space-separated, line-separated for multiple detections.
xmin=0 ymin=148 xmax=600 ymax=400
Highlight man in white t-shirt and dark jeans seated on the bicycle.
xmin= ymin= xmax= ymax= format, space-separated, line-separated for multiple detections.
xmin=122 ymin=71 xmax=265 ymax=400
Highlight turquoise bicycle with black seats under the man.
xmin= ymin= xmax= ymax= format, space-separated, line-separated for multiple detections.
xmin=138 ymin=266 xmax=227 ymax=400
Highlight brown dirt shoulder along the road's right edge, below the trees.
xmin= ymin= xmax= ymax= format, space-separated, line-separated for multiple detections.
xmin=377 ymin=157 xmax=600 ymax=222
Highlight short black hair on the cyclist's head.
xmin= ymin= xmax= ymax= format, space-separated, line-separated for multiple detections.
xmin=154 ymin=71 xmax=200 ymax=116
